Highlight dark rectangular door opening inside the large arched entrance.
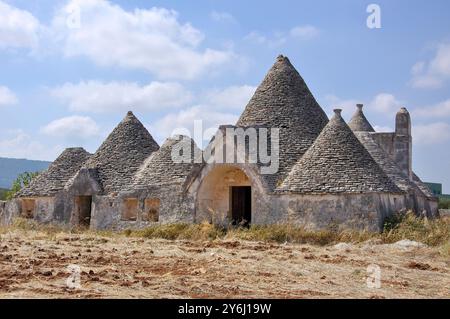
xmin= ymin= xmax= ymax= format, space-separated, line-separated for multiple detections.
xmin=231 ymin=186 xmax=252 ymax=226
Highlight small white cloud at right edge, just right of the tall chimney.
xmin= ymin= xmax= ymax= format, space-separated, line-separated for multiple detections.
xmin=412 ymin=122 xmax=450 ymax=145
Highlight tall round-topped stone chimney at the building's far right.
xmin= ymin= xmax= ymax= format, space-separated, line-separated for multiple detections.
xmin=394 ymin=107 xmax=412 ymax=180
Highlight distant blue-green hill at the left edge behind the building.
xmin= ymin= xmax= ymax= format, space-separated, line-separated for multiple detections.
xmin=0 ymin=157 xmax=50 ymax=188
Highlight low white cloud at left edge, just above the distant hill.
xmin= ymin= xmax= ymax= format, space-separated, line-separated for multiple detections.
xmin=0 ymin=130 xmax=63 ymax=161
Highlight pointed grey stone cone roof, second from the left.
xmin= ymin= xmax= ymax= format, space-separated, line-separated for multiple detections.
xmin=85 ymin=112 xmax=159 ymax=194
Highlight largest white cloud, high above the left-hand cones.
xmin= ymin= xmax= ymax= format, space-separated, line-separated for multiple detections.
xmin=52 ymin=0 xmax=234 ymax=79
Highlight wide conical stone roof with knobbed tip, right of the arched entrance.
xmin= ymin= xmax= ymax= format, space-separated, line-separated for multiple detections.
xmin=279 ymin=110 xmax=401 ymax=194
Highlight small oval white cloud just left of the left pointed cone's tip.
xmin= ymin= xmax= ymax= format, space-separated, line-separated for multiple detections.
xmin=41 ymin=115 xmax=100 ymax=139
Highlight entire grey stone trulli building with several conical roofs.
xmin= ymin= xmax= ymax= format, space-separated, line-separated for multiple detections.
xmin=0 ymin=56 xmax=438 ymax=231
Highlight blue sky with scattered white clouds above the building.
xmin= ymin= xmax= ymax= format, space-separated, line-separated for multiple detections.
xmin=0 ymin=0 xmax=450 ymax=193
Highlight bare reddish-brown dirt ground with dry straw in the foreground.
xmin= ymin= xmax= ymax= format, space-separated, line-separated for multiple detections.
xmin=0 ymin=231 xmax=450 ymax=298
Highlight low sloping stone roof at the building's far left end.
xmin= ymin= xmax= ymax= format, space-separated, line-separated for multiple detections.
xmin=16 ymin=147 xmax=91 ymax=197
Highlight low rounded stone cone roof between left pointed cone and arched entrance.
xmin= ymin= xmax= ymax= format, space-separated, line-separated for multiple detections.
xmin=130 ymin=135 xmax=202 ymax=190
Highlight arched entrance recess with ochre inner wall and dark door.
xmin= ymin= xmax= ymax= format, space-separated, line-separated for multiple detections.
xmin=195 ymin=165 xmax=255 ymax=226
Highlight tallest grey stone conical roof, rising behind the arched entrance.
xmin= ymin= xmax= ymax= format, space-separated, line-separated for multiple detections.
xmin=236 ymin=55 xmax=328 ymax=190
